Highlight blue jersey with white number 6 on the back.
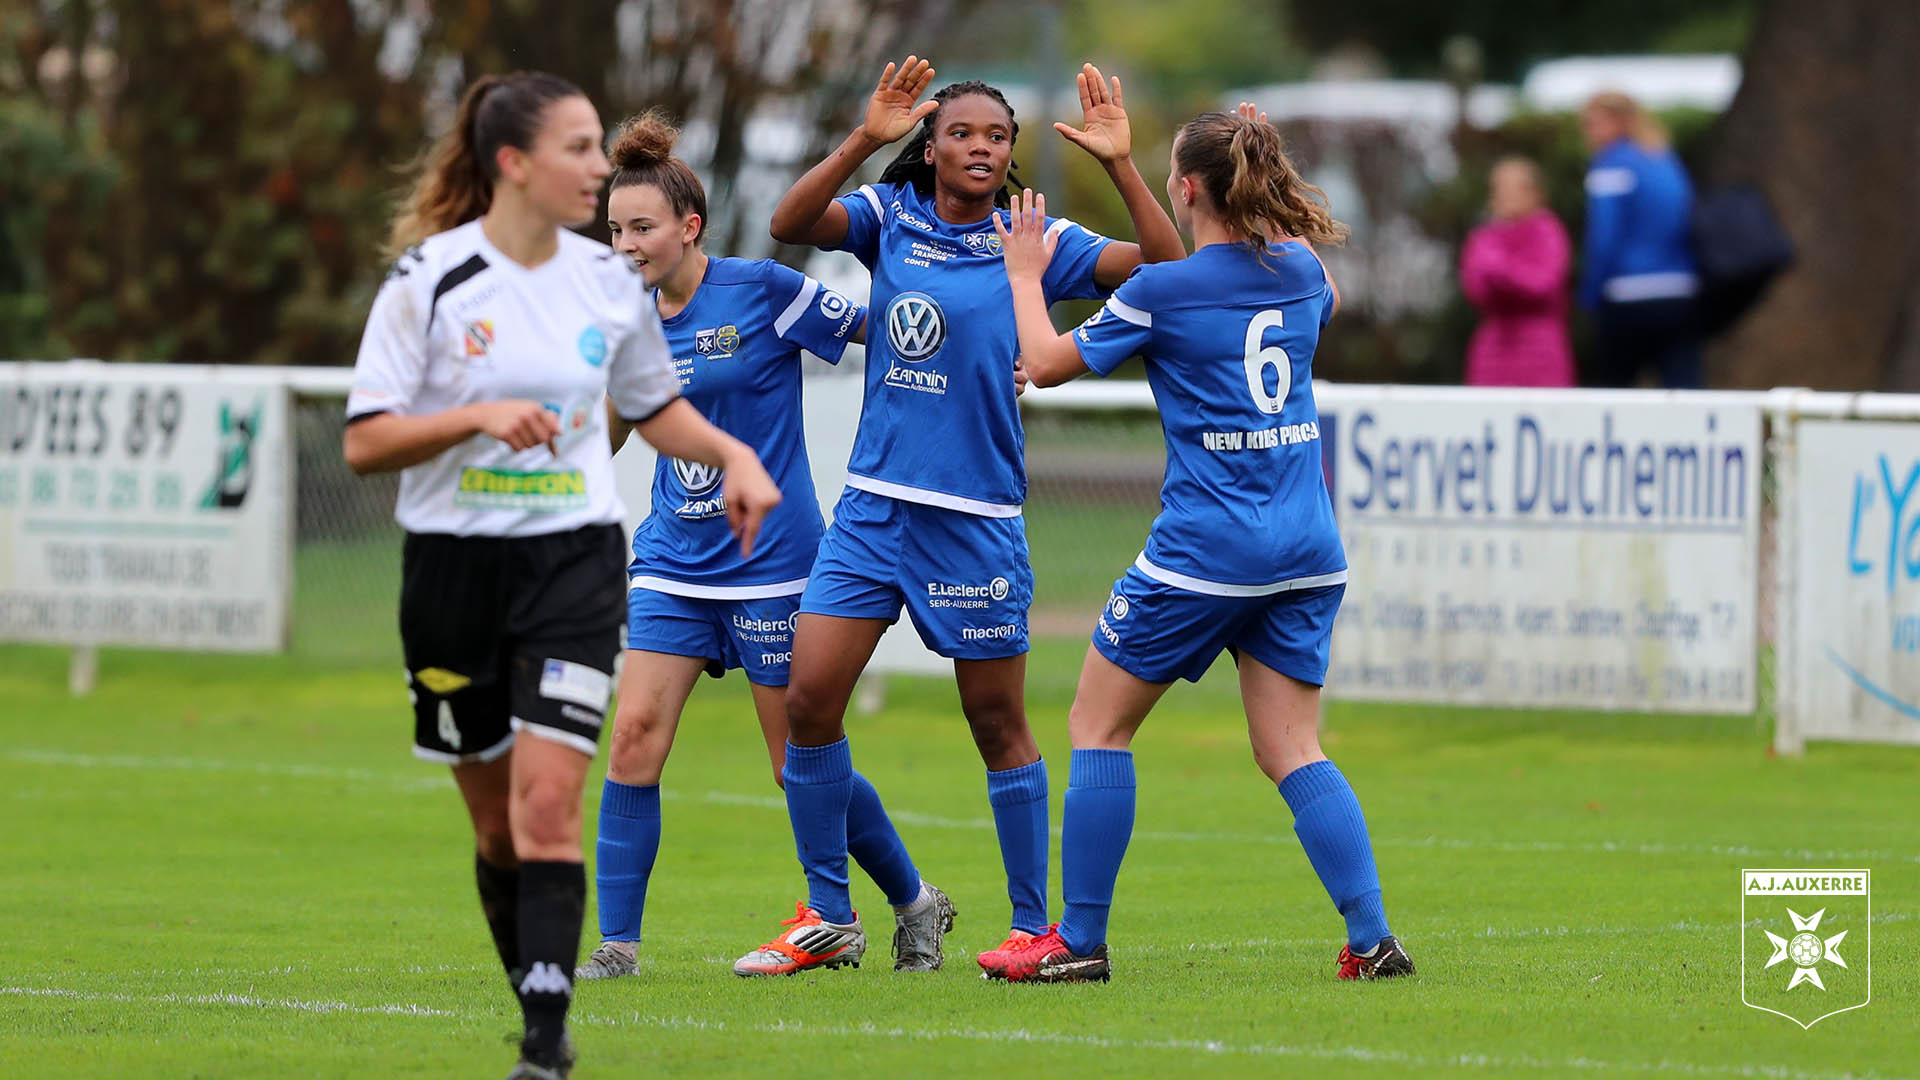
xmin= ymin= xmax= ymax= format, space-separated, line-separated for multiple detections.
xmin=1073 ymin=244 xmax=1346 ymax=596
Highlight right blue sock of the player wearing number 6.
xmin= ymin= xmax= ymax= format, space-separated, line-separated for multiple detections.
xmin=1281 ymin=761 xmax=1388 ymax=953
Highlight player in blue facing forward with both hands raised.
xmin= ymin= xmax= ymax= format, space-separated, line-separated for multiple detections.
xmin=762 ymin=56 xmax=1185 ymax=970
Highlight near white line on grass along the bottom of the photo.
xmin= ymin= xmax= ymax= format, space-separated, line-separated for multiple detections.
xmin=0 ymin=986 xmax=1847 ymax=1080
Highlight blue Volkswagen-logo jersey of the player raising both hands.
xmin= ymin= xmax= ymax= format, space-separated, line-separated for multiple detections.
xmin=839 ymin=184 xmax=1110 ymax=517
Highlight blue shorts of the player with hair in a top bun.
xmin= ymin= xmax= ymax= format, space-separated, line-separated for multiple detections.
xmin=626 ymin=586 xmax=801 ymax=686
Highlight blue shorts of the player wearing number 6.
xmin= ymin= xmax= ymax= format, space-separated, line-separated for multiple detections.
xmin=1092 ymin=567 xmax=1346 ymax=686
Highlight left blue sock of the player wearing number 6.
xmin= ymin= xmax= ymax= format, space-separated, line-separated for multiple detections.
xmin=1060 ymin=749 xmax=1137 ymax=957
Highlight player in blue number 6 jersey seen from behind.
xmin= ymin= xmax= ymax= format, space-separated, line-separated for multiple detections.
xmin=983 ymin=106 xmax=1413 ymax=982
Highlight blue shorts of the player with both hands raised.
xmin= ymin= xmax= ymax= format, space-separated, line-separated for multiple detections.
xmin=801 ymin=488 xmax=1033 ymax=659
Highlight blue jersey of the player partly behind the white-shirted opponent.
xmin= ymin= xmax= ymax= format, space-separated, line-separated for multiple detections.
xmin=630 ymin=259 xmax=866 ymax=600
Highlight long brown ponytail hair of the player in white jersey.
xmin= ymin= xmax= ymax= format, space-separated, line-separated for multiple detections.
xmin=386 ymin=71 xmax=584 ymax=258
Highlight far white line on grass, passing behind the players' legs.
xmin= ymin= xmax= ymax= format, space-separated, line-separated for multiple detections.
xmin=0 ymin=748 xmax=1920 ymax=863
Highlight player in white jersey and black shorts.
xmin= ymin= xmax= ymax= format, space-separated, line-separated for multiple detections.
xmin=346 ymin=73 xmax=780 ymax=1080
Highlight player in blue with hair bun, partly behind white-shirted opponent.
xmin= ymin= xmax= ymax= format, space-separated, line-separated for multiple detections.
xmin=580 ymin=113 xmax=952 ymax=978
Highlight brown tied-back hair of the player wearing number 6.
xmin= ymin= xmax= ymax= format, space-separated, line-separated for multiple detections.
xmin=1173 ymin=113 xmax=1348 ymax=261
